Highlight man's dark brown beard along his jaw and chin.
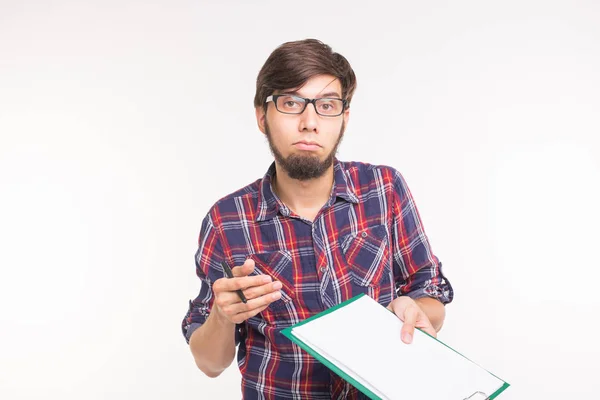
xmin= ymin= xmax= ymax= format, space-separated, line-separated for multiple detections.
xmin=265 ymin=121 xmax=346 ymax=181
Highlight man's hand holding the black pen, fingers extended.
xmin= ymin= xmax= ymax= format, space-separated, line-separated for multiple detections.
xmin=213 ymin=259 xmax=281 ymax=324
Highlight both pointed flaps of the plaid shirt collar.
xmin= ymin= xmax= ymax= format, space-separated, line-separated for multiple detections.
xmin=256 ymin=158 xmax=358 ymax=221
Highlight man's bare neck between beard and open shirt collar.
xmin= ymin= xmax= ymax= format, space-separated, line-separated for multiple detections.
xmin=273 ymin=164 xmax=333 ymax=216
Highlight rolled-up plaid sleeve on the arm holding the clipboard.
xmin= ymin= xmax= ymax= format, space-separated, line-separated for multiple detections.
xmin=392 ymin=171 xmax=454 ymax=304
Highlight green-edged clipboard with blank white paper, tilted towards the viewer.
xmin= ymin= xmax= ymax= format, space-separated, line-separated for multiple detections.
xmin=281 ymin=294 xmax=510 ymax=400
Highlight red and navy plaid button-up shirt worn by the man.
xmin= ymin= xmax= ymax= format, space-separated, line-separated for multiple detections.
xmin=182 ymin=160 xmax=453 ymax=399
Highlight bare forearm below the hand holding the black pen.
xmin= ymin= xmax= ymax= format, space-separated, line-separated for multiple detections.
xmin=190 ymin=308 xmax=235 ymax=378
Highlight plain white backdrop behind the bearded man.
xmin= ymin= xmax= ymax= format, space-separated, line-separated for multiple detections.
xmin=0 ymin=0 xmax=600 ymax=400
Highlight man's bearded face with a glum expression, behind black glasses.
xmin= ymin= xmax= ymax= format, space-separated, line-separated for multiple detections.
xmin=256 ymin=75 xmax=349 ymax=180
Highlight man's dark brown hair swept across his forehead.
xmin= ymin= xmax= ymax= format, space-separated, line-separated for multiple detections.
xmin=254 ymin=39 xmax=356 ymax=107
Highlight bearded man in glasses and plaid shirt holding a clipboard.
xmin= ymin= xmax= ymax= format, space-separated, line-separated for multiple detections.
xmin=182 ymin=40 xmax=453 ymax=399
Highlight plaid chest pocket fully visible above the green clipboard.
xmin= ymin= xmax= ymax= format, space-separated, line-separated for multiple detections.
xmin=340 ymin=225 xmax=391 ymax=293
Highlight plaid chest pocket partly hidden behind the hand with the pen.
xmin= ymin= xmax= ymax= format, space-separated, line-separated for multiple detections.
xmin=248 ymin=250 xmax=296 ymax=314
